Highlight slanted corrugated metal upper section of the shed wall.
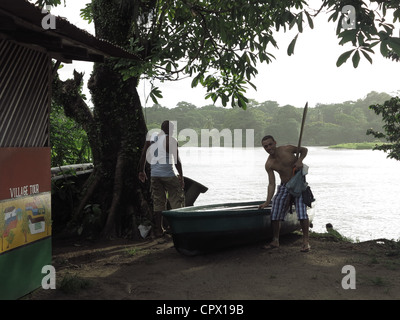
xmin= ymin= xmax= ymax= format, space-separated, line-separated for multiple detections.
xmin=0 ymin=39 xmax=51 ymax=147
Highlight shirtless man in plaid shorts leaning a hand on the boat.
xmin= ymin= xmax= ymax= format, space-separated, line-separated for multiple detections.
xmin=259 ymin=135 xmax=310 ymax=252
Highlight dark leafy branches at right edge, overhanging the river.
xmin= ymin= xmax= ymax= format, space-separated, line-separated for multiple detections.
xmin=367 ymin=97 xmax=400 ymax=160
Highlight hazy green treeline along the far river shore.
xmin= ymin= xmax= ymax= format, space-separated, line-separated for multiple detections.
xmin=144 ymin=92 xmax=391 ymax=146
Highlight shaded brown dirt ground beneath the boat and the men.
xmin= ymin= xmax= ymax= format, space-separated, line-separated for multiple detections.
xmin=23 ymin=234 xmax=400 ymax=301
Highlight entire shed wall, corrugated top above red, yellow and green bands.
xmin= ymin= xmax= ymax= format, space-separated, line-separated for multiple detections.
xmin=0 ymin=38 xmax=52 ymax=300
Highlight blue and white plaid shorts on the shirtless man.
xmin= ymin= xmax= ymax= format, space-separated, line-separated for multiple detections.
xmin=271 ymin=183 xmax=308 ymax=221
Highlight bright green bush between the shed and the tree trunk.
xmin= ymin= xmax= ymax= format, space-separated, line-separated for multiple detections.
xmin=50 ymin=103 xmax=92 ymax=167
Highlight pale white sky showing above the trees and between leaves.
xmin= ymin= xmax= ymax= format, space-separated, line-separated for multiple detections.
xmin=47 ymin=0 xmax=400 ymax=108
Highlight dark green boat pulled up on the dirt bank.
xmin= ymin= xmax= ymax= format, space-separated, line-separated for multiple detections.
xmin=163 ymin=201 xmax=314 ymax=256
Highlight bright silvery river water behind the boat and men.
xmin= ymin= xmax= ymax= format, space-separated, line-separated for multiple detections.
xmin=179 ymin=147 xmax=400 ymax=241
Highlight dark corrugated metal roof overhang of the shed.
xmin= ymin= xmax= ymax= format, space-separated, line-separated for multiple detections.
xmin=0 ymin=0 xmax=141 ymax=62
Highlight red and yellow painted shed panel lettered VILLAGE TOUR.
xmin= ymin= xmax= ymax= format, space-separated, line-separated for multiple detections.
xmin=0 ymin=148 xmax=51 ymax=255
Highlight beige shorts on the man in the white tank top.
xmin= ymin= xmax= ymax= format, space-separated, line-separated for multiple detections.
xmin=150 ymin=176 xmax=185 ymax=211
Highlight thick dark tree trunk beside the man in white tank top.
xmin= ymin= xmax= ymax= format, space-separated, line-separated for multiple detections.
xmin=52 ymin=0 xmax=155 ymax=238
